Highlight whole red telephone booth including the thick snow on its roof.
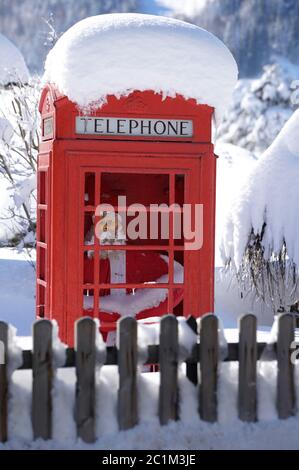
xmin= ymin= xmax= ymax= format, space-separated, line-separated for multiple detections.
xmin=37 ymin=14 xmax=237 ymax=344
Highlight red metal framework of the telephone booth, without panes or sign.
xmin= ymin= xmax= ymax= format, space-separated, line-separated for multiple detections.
xmin=37 ymin=85 xmax=216 ymax=344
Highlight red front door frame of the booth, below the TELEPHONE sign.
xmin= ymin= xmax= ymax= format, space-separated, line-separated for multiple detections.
xmin=48 ymin=140 xmax=216 ymax=344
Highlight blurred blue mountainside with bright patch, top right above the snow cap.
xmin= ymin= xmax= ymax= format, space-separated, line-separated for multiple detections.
xmin=165 ymin=0 xmax=299 ymax=77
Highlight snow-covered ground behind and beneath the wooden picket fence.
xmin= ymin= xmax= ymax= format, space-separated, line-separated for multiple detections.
xmin=0 ymin=248 xmax=288 ymax=450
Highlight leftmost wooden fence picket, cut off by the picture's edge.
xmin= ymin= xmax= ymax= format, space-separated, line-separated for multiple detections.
xmin=0 ymin=321 xmax=9 ymax=442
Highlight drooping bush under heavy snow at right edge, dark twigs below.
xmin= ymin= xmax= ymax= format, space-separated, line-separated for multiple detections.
xmin=222 ymin=110 xmax=299 ymax=311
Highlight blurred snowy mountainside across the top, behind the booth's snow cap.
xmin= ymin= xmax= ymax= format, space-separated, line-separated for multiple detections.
xmin=0 ymin=0 xmax=299 ymax=76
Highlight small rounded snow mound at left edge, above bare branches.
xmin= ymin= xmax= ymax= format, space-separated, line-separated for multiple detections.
xmin=0 ymin=34 xmax=29 ymax=86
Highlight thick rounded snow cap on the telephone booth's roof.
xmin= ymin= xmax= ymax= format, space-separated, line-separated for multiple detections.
xmin=44 ymin=13 xmax=238 ymax=123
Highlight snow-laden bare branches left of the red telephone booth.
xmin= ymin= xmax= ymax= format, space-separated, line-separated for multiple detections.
xmin=0 ymin=80 xmax=39 ymax=248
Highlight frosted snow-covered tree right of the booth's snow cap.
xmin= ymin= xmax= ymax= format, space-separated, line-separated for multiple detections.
xmin=218 ymin=63 xmax=299 ymax=153
